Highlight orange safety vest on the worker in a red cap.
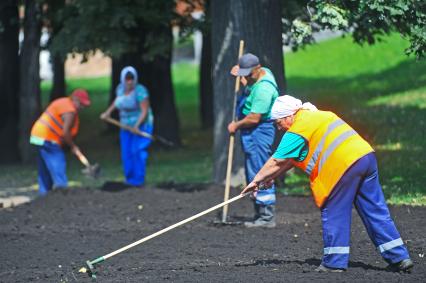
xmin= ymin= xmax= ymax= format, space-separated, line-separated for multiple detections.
xmin=31 ymin=97 xmax=80 ymax=145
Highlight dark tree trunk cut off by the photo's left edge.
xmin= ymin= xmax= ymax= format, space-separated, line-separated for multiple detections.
xmin=0 ymin=0 xmax=19 ymax=163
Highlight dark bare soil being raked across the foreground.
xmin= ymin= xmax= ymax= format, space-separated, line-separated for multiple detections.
xmin=0 ymin=185 xmax=426 ymax=282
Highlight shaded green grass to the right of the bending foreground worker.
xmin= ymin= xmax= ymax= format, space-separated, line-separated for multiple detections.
xmin=288 ymin=60 xmax=426 ymax=203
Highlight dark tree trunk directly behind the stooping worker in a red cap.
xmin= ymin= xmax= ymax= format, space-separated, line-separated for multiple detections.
xmin=19 ymin=0 xmax=41 ymax=162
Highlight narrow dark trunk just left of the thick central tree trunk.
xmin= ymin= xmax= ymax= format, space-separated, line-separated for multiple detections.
xmin=200 ymin=1 xmax=213 ymax=128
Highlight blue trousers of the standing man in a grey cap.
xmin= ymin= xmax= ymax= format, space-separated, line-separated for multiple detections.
xmin=241 ymin=122 xmax=275 ymax=205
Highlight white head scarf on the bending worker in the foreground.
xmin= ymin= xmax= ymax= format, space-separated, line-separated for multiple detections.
xmin=271 ymin=95 xmax=318 ymax=120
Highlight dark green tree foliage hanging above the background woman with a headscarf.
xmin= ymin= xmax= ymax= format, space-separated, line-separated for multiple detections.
xmin=52 ymin=0 xmax=177 ymax=59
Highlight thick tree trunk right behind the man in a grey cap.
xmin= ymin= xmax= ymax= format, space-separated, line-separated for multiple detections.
xmin=212 ymin=0 xmax=285 ymax=185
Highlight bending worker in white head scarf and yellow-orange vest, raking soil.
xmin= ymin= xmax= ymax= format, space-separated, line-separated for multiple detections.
xmin=242 ymin=95 xmax=413 ymax=272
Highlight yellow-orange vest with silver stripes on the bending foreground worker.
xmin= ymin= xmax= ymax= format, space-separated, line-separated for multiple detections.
xmin=288 ymin=110 xmax=374 ymax=207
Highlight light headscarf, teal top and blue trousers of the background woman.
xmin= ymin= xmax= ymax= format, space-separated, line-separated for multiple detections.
xmin=114 ymin=67 xmax=154 ymax=186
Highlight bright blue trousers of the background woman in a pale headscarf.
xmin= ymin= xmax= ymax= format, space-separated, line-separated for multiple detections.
xmin=120 ymin=124 xmax=153 ymax=186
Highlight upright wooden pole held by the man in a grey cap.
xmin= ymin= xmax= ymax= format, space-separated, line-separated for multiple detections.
xmin=222 ymin=40 xmax=244 ymax=222
